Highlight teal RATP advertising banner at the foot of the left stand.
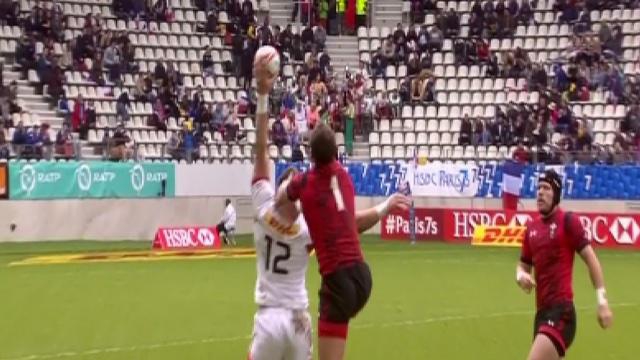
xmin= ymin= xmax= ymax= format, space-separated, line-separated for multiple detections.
xmin=9 ymin=161 xmax=175 ymax=200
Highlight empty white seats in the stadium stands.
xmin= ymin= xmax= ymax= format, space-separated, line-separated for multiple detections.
xmin=0 ymin=0 xmax=640 ymax=165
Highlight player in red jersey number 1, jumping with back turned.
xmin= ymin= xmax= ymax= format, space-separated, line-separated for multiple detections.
xmin=276 ymin=124 xmax=410 ymax=360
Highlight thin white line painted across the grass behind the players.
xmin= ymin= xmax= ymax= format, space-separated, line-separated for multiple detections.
xmin=0 ymin=303 xmax=640 ymax=360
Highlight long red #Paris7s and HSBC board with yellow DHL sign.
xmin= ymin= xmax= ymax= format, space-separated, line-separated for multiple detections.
xmin=381 ymin=208 xmax=640 ymax=250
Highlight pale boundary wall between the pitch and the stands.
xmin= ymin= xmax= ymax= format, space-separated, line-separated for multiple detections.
xmin=0 ymin=197 xmax=640 ymax=242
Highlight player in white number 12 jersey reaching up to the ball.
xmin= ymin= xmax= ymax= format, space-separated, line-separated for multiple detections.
xmin=249 ymin=55 xmax=409 ymax=360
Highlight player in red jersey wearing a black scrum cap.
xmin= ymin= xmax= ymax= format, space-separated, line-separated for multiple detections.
xmin=516 ymin=170 xmax=613 ymax=360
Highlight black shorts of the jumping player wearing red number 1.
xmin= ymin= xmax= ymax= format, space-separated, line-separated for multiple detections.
xmin=319 ymin=262 xmax=372 ymax=324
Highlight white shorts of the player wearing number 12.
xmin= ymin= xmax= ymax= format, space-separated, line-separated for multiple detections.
xmin=249 ymin=308 xmax=312 ymax=360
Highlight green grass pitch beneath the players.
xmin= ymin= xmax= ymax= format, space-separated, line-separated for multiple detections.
xmin=0 ymin=237 xmax=640 ymax=360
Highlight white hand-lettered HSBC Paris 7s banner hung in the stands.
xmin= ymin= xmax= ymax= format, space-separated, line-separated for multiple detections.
xmin=404 ymin=164 xmax=480 ymax=197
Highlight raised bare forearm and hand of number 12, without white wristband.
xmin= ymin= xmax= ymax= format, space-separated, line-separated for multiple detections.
xmin=253 ymin=58 xmax=274 ymax=184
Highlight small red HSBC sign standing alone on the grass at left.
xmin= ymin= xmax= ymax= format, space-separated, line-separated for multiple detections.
xmin=153 ymin=226 xmax=222 ymax=250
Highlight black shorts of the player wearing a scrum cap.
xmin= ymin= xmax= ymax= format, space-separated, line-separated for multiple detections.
xmin=533 ymin=303 xmax=576 ymax=357
